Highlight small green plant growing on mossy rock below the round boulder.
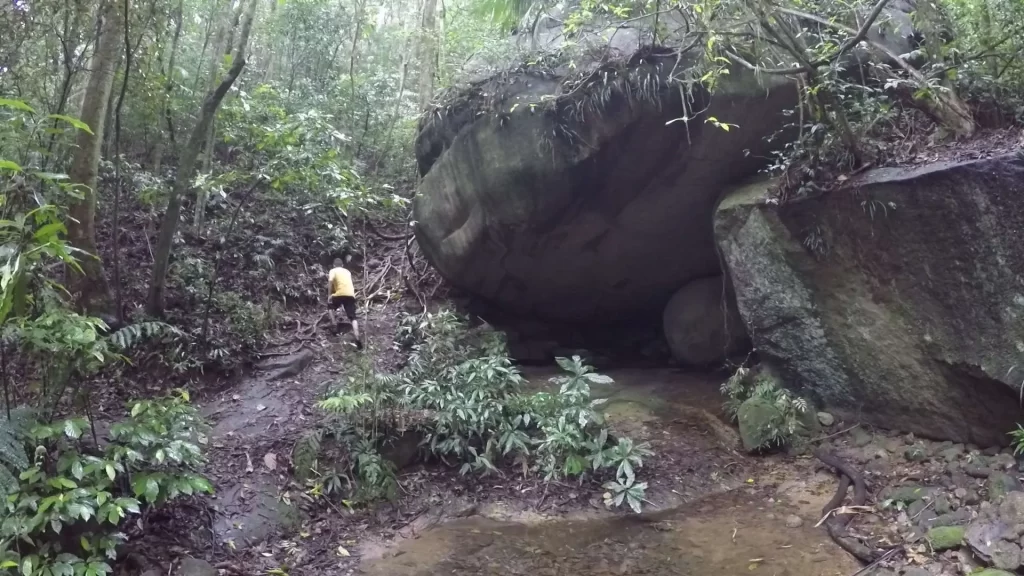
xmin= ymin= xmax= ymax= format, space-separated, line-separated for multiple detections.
xmin=721 ymin=366 xmax=810 ymax=446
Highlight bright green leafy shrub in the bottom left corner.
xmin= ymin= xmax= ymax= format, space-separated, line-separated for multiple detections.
xmin=0 ymin=392 xmax=213 ymax=576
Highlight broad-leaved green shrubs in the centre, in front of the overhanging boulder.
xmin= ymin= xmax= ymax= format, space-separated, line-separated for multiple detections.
xmin=307 ymin=311 xmax=652 ymax=510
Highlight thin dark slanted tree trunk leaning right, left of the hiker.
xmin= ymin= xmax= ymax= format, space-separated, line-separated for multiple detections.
xmin=146 ymin=0 xmax=258 ymax=317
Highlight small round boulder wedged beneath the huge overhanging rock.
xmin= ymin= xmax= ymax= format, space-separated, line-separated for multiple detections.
xmin=662 ymin=276 xmax=748 ymax=366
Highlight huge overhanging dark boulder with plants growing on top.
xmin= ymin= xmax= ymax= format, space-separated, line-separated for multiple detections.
xmin=414 ymin=51 xmax=797 ymax=323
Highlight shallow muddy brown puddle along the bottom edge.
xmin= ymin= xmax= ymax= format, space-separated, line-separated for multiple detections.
xmin=361 ymin=490 xmax=859 ymax=576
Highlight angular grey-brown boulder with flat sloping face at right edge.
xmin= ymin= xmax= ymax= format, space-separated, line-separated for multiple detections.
xmin=715 ymin=155 xmax=1024 ymax=446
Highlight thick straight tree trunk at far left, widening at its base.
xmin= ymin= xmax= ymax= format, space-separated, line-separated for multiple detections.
xmin=66 ymin=0 xmax=121 ymax=314
